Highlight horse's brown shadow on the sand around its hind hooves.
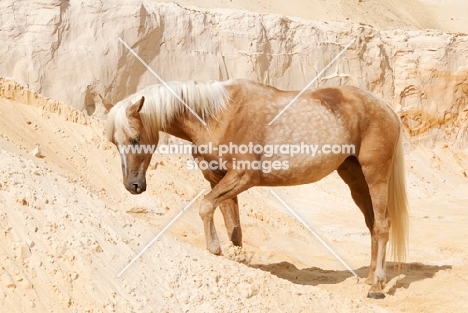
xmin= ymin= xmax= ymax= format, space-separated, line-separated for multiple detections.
xmin=250 ymin=262 xmax=452 ymax=294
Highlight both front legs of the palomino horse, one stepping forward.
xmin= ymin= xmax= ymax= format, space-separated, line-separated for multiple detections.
xmin=200 ymin=170 xmax=258 ymax=254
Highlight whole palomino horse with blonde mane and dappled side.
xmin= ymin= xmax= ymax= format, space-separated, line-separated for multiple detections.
xmin=107 ymin=80 xmax=408 ymax=298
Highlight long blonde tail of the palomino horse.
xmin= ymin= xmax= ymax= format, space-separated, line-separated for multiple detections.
xmin=388 ymin=130 xmax=409 ymax=267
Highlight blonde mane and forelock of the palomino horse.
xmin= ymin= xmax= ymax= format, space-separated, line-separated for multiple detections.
xmin=107 ymin=81 xmax=229 ymax=142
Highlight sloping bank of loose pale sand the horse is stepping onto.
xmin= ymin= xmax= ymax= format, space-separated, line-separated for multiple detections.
xmin=0 ymin=81 xmax=394 ymax=312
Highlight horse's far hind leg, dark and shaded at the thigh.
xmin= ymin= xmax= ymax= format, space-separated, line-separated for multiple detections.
xmin=337 ymin=156 xmax=377 ymax=284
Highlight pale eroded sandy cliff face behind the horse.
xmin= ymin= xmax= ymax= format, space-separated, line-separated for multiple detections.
xmin=0 ymin=0 xmax=468 ymax=147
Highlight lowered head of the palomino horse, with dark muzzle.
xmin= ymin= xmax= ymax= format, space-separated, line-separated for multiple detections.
xmin=107 ymin=97 xmax=159 ymax=194
